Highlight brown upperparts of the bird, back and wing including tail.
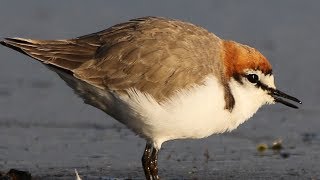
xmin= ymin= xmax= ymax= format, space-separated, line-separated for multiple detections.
xmin=2 ymin=17 xmax=222 ymax=101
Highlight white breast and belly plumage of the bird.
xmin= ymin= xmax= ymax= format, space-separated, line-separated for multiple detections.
xmin=121 ymin=77 xmax=268 ymax=148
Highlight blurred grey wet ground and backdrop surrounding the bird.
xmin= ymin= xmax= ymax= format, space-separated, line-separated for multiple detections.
xmin=0 ymin=0 xmax=320 ymax=179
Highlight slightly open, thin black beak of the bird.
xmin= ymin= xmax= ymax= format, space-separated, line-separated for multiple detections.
xmin=268 ymin=88 xmax=302 ymax=109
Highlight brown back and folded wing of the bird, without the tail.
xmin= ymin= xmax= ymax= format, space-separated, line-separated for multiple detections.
xmin=74 ymin=17 xmax=225 ymax=101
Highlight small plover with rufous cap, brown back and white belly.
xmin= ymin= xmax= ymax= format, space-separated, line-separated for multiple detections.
xmin=0 ymin=16 xmax=302 ymax=180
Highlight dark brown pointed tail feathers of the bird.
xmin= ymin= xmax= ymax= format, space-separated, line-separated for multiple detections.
xmin=0 ymin=38 xmax=97 ymax=71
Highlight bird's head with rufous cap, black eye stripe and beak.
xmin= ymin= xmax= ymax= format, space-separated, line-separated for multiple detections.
xmin=223 ymin=41 xmax=301 ymax=108
